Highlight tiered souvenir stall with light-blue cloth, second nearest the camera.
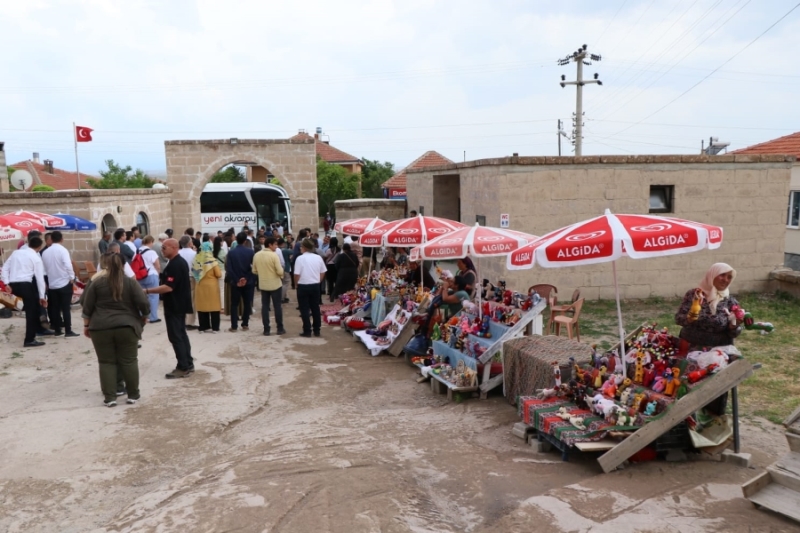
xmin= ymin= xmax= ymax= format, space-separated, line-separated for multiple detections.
xmin=412 ymin=300 xmax=546 ymax=399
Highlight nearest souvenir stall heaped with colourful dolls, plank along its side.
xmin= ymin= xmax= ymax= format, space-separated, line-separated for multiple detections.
xmin=517 ymin=326 xmax=753 ymax=472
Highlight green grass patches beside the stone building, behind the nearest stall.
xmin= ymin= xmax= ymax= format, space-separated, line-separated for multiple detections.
xmin=580 ymin=293 xmax=800 ymax=424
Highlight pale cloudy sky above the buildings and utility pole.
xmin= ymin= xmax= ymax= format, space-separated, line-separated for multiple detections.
xmin=0 ymin=0 xmax=800 ymax=177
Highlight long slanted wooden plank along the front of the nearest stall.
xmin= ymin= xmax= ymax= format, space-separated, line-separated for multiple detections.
xmin=597 ymin=359 xmax=753 ymax=473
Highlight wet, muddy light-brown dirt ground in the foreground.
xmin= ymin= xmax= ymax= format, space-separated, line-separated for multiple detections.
xmin=0 ymin=305 xmax=799 ymax=533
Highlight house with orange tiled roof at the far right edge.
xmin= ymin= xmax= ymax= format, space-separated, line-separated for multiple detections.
xmin=731 ymin=132 xmax=800 ymax=270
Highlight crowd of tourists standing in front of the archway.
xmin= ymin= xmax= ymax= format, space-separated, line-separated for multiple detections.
xmin=0 ymin=223 xmax=346 ymax=407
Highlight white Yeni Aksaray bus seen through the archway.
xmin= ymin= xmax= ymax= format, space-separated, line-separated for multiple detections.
xmin=200 ymin=182 xmax=292 ymax=235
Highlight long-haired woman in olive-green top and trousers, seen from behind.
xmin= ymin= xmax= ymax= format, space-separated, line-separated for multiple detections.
xmin=81 ymin=252 xmax=150 ymax=407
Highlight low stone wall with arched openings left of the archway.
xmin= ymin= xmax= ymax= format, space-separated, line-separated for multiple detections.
xmin=0 ymin=189 xmax=173 ymax=262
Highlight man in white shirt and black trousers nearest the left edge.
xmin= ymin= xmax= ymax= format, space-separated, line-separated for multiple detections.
xmin=2 ymin=237 xmax=47 ymax=348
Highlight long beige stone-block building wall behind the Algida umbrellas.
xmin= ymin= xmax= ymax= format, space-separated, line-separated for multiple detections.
xmin=408 ymin=155 xmax=794 ymax=299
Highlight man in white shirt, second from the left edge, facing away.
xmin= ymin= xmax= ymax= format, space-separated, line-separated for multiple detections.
xmin=42 ymin=231 xmax=80 ymax=337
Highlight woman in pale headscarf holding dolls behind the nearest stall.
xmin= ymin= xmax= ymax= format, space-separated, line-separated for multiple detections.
xmin=675 ymin=263 xmax=742 ymax=348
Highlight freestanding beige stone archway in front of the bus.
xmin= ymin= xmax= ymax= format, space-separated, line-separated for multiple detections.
xmin=164 ymin=139 xmax=319 ymax=233
